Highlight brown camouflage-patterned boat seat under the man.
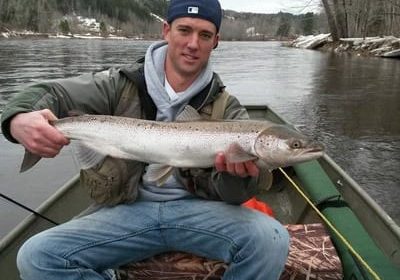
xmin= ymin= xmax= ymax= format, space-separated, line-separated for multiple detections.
xmin=120 ymin=223 xmax=343 ymax=280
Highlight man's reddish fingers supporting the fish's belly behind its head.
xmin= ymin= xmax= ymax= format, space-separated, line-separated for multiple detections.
xmin=214 ymin=153 xmax=260 ymax=178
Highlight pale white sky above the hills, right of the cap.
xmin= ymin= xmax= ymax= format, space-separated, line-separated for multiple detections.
xmin=219 ymin=0 xmax=321 ymax=14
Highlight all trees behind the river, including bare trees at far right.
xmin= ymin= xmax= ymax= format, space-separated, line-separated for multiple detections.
xmin=0 ymin=0 xmax=400 ymax=40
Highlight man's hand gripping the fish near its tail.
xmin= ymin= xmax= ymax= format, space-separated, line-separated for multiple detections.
xmin=10 ymin=109 xmax=69 ymax=157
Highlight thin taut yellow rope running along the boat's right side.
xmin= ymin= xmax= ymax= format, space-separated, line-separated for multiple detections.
xmin=279 ymin=168 xmax=381 ymax=280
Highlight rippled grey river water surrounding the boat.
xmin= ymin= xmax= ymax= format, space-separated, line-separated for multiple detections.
xmin=0 ymin=39 xmax=400 ymax=238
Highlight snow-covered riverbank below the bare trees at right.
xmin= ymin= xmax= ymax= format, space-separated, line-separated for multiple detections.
xmin=285 ymin=33 xmax=400 ymax=59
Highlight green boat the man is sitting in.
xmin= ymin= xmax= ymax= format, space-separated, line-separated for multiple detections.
xmin=0 ymin=105 xmax=400 ymax=280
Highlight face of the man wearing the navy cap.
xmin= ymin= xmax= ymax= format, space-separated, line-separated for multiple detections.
xmin=163 ymin=17 xmax=219 ymax=78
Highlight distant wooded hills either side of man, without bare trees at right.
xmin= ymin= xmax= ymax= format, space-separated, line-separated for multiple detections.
xmin=0 ymin=0 xmax=327 ymax=40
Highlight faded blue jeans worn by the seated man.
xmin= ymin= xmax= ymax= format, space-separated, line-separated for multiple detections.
xmin=17 ymin=198 xmax=289 ymax=280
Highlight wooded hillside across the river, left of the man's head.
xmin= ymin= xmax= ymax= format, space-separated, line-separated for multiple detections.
xmin=0 ymin=0 xmax=167 ymax=35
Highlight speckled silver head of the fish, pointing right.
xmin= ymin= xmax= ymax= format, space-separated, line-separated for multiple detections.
xmin=254 ymin=125 xmax=325 ymax=169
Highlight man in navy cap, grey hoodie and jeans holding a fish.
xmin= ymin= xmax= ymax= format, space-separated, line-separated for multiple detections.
xmin=2 ymin=0 xmax=288 ymax=280
